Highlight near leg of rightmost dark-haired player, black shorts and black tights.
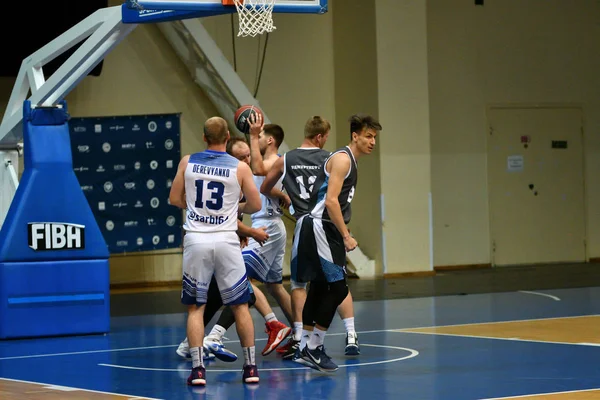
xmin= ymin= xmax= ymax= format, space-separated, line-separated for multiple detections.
xmin=302 ymin=219 xmax=348 ymax=372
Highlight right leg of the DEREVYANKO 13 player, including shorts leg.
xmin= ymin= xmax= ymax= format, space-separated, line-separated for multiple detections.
xmin=215 ymin=232 xmax=259 ymax=383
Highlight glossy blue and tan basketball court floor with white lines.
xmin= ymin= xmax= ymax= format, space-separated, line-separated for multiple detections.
xmin=0 ymin=287 xmax=600 ymax=400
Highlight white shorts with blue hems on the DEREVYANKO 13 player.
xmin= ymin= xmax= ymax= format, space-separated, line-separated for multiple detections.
xmin=181 ymin=232 xmax=250 ymax=305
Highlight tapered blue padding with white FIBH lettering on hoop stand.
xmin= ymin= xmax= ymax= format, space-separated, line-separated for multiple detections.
xmin=0 ymin=101 xmax=109 ymax=263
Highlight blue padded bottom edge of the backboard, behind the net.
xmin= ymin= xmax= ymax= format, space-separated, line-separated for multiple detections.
xmin=126 ymin=0 xmax=327 ymax=15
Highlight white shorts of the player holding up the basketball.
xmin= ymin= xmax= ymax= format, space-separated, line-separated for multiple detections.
xmin=242 ymin=218 xmax=287 ymax=283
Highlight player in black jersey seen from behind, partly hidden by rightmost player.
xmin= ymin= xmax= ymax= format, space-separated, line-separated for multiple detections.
xmin=260 ymin=116 xmax=360 ymax=360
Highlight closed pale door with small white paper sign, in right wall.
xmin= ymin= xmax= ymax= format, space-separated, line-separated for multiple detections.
xmin=487 ymin=107 xmax=586 ymax=265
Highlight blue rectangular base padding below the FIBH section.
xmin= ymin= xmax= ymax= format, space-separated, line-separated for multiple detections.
xmin=0 ymin=260 xmax=110 ymax=339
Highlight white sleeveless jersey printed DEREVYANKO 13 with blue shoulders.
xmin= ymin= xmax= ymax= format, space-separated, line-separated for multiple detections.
xmin=183 ymin=150 xmax=241 ymax=232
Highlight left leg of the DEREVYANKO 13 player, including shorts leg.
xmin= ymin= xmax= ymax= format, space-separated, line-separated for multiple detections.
xmin=181 ymin=234 xmax=215 ymax=385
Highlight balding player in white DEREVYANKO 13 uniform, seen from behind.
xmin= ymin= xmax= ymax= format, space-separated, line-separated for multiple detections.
xmin=169 ymin=117 xmax=261 ymax=385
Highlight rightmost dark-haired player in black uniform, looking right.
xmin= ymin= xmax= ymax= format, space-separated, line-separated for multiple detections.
xmin=297 ymin=115 xmax=382 ymax=372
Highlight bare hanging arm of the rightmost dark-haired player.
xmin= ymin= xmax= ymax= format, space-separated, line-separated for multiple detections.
xmin=325 ymin=153 xmax=356 ymax=251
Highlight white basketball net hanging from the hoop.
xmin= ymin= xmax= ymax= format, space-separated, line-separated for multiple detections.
xmin=234 ymin=0 xmax=276 ymax=36
